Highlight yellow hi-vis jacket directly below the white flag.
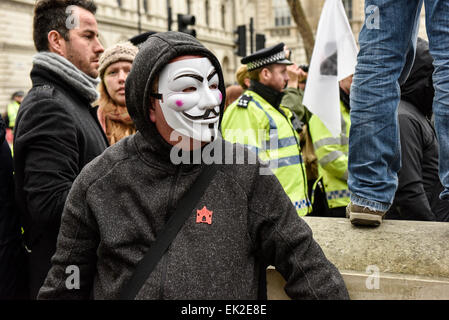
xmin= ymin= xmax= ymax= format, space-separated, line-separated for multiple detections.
xmin=309 ymin=102 xmax=351 ymax=208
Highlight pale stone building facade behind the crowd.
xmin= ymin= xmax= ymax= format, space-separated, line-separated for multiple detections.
xmin=0 ymin=0 xmax=424 ymax=112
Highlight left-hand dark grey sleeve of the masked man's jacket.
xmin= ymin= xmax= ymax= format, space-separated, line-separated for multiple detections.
xmin=38 ymin=172 xmax=100 ymax=300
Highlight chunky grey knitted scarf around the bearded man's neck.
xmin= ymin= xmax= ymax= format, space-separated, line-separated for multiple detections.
xmin=33 ymin=52 xmax=100 ymax=103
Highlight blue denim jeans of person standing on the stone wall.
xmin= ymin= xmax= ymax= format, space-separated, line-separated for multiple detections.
xmin=348 ymin=0 xmax=449 ymax=211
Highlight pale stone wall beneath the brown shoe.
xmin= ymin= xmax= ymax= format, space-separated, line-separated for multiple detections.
xmin=267 ymin=217 xmax=449 ymax=300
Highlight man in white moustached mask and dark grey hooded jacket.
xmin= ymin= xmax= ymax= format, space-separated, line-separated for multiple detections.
xmin=39 ymin=32 xmax=348 ymax=300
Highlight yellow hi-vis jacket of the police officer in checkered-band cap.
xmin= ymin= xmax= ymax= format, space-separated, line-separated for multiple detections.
xmin=221 ymin=90 xmax=312 ymax=216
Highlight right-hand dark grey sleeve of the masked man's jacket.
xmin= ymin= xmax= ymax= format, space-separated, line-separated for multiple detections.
xmin=249 ymin=165 xmax=349 ymax=300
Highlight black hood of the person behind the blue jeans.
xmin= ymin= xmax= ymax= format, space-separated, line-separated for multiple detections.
xmin=401 ymin=38 xmax=435 ymax=117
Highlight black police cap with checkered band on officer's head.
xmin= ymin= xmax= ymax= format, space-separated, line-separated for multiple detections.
xmin=241 ymin=42 xmax=293 ymax=71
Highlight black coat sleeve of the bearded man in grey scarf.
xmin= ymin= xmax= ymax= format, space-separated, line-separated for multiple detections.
xmin=17 ymin=99 xmax=80 ymax=230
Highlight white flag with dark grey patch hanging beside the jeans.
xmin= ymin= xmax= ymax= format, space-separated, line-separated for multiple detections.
xmin=303 ymin=0 xmax=358 ymax=137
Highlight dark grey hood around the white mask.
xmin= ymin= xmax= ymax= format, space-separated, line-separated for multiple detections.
xmin=125 ymin=31 xmax=226 ymax=153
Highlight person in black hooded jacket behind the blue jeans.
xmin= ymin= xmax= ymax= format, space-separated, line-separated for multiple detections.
xmin=386 ymin=38 xmax=449 ymax=221
